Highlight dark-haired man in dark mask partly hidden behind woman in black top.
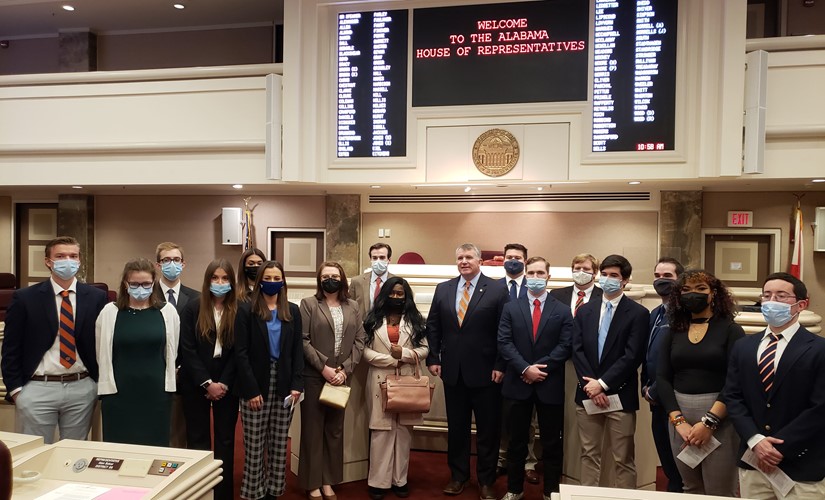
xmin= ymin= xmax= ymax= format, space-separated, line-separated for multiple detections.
xmin=641 ymin=257 xmax=685 ymax=493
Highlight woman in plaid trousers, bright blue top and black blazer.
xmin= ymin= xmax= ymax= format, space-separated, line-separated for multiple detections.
xmin=237 ymin=261 xmax=304 ymax=500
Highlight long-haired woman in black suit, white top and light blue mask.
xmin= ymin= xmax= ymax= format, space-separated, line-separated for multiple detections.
xmin=178 ymin=259 xmax=238 ymax=500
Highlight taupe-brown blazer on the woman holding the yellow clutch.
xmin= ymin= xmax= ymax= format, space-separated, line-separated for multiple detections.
xmin=300 ymin=295 xmax=366 ymax=378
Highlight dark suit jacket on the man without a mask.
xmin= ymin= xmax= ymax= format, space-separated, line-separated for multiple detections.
xmin=427 ymin=274 xmax=510 ymax=387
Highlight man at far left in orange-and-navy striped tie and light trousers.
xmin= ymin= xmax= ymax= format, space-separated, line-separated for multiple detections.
xmin=2 ymin=236 xmax=106 ymax=444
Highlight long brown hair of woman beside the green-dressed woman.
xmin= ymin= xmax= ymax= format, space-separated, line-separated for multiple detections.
xmin=197 ymin=259 xmax=238 ymax=346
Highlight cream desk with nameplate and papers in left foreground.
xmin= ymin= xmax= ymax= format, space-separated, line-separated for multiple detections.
xmin=13 ymin=439 xmax=221 ymax=500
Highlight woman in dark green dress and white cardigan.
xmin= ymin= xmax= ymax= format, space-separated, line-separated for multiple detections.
xmin=95 ymin=259 xmax=180 ymax=446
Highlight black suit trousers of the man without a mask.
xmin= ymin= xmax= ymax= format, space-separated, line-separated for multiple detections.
xmin=444 ymin=377 xmax=502 ymax=485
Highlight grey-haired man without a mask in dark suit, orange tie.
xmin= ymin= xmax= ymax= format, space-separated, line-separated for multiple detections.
xmin=427 ymin=243 xmax=509 ymax=500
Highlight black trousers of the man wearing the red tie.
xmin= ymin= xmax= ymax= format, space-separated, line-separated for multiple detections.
xmin=505 ymin=393 xmax=564 ymax=496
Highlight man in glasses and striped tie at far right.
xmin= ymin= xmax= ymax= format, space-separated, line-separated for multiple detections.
xmin=725 ymin=273 xmax=825 ymax=500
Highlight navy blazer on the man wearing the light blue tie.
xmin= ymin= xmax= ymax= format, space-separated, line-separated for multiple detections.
xmin=573 ymin=295 xmax=650 ymax=411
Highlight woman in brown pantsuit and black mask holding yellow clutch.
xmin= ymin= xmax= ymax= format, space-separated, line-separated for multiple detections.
xmin=298 ymin=262 xmax=364 ymax=500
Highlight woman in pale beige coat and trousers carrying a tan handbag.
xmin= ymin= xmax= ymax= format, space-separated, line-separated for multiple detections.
xmin=364 ymin=276 xmax=429 ymax=500
